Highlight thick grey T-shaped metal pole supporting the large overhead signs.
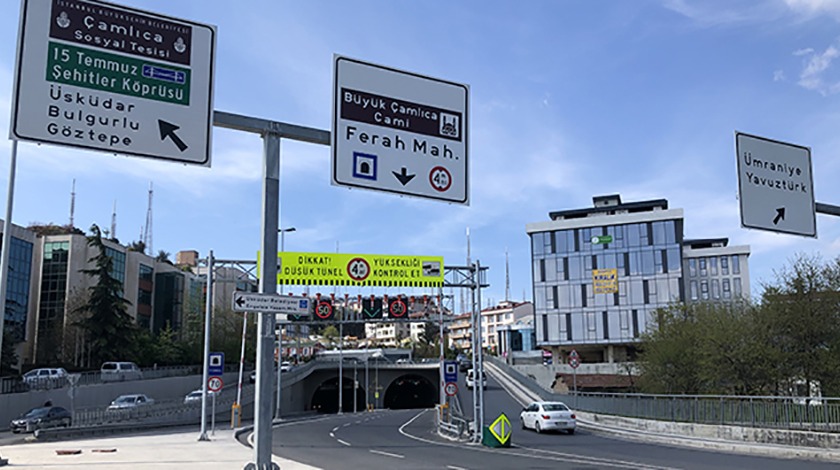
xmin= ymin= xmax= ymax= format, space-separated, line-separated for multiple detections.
xmin=213 ymin=111 xmax=330 ymax=470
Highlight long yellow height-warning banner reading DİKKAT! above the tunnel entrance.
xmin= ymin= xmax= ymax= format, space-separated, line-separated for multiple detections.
xmin=257 ymin=252 xmax=443 ymax=287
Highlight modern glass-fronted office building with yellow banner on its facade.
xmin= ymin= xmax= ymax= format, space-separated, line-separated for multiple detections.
xmin=526 ymin=195 xmax=749 ymax=364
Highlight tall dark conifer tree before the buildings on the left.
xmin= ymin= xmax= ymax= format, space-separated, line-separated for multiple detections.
xmin=76 ymin=224 xmax=135 ymax=364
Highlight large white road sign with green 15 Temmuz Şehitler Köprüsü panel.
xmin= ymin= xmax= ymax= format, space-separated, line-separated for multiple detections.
xmin=10 ymin=0 xmax=216 ymax=166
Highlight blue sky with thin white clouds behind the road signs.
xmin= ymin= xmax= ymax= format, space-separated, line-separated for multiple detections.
xmin=0 ymin=0 xmax=840 ymax=312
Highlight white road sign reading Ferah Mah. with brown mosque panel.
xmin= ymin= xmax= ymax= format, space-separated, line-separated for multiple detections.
xmin=332 ymin=56 xmax=469 ymax=205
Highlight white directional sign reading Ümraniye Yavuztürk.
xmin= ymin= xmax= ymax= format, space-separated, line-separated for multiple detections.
xmin=735 ymin=132 xmax=817 ymax=237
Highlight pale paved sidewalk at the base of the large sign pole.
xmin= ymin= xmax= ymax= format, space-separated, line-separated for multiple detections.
xmin=0 ymin=428 xmax=314 ymax=470
